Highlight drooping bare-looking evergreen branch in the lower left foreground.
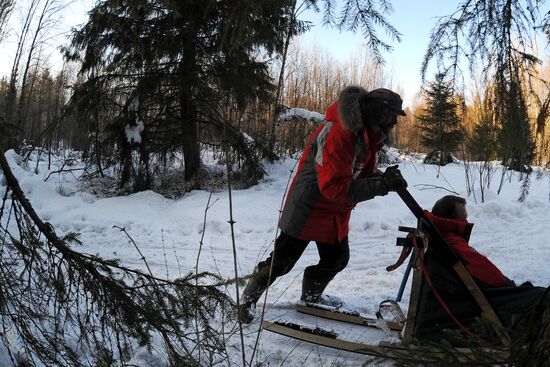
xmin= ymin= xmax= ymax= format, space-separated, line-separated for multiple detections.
xmin=0 ymin=151 xmax=233 ymax=366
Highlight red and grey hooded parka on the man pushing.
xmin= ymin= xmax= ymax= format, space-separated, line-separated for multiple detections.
xmin=279 ymin=87 xmax=384 ymax=243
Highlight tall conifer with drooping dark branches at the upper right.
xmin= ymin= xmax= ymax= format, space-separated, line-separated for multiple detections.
xmin=422 ymin=0 xmax=550 ymax=171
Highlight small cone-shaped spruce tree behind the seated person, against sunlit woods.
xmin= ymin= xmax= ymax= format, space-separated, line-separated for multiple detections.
xmin=417 ymin=73 xmax=463 ymax=166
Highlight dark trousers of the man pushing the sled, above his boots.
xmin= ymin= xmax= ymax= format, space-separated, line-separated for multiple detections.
xmin=254 ymin=232 xmax=349 ymax=286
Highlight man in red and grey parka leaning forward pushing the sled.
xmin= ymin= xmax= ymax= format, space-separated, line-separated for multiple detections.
xmin=239 ymin=86 xmax=406 ymax=323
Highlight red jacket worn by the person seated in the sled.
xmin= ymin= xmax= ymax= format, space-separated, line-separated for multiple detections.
xmin=424 ymin=210 xmax=508 ymax=287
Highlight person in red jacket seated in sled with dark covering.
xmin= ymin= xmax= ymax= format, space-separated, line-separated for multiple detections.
xmin=415 ymin=195 xmax=550 ymax=340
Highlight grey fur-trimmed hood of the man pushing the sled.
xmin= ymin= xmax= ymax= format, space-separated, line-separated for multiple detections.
xmin=326 ymin=85 xmax=368 ymax=132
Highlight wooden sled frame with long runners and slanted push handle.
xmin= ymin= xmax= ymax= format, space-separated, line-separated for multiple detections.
xmin=262 ymin=184 xmax=510 ymax=363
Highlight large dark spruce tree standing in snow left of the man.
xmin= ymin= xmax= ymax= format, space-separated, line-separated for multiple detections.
xmin=67 ymin=0 xmax=302 ymax=190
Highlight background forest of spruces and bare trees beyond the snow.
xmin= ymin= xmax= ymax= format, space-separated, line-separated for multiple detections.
xmin=0 ymin=0 xmax=550 ymax=196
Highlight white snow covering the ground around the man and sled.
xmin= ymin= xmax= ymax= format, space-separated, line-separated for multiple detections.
xmin=0 ymin=151 xmax=550 ymax=366
